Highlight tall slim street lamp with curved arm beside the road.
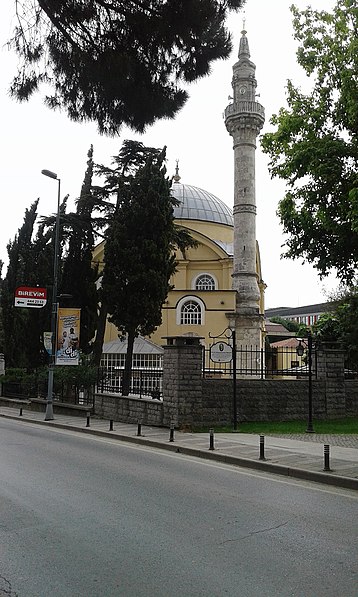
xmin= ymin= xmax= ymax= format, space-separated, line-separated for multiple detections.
xmin=41 ymin=170 xmax=61 ymax=421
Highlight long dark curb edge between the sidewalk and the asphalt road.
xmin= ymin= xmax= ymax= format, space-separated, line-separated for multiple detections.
xmin=0 ymin=413 xmax=358 ymax=490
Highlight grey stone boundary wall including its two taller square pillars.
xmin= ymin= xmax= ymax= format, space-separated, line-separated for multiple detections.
xmin=95 ymin=336 xmax=358 ymax=429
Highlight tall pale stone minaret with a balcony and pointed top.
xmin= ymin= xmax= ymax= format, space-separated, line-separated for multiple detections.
xmin=225 ymin=26 xmax=265 ymax=347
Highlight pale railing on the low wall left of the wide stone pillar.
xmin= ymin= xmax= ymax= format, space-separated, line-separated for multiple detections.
xmin=97 ymin=369 xmax=163 ymax=400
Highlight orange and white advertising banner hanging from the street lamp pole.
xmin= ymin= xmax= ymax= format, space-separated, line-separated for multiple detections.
xmin=56 ymin=308 xmax=81 ymax=365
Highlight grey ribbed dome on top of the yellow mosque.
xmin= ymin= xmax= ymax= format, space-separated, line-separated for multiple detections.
xmin=171 ymin=181 xmax=234 ymax=227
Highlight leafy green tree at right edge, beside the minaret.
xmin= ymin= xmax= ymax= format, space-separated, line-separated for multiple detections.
xmin=262 ymin=0 xmax=358 ymax=282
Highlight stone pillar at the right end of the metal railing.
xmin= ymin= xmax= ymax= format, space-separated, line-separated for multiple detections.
xmin=317 ymin=345 xmax=346 ymax=419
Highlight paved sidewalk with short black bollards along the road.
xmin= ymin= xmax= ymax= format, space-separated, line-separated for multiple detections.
xmin=0 ymin=407 xmax=358 ymax=489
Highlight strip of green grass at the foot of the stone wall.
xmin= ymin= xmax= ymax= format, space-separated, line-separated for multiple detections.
xmin=195 ymin=417 xmax=358 ymax=435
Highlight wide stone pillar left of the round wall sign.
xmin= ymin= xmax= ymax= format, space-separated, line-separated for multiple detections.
xmin=163 ymin=336 xmax=203 ymax=429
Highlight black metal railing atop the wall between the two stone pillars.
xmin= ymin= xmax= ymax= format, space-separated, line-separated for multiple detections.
xmin=203 ymin=346 xmax=317 ymax=379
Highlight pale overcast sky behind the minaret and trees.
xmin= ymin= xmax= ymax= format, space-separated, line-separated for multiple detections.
xmin=0 ymin=0 xmax=337 ymax=308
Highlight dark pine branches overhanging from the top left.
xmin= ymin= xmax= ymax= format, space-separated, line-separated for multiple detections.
xmin=10 ymin=0 xmax=245 ymax=134
